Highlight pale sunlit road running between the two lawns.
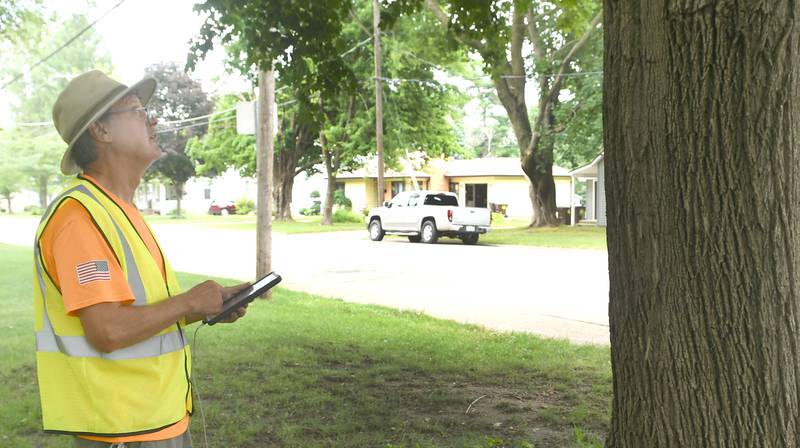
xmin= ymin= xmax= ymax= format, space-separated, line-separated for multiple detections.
xmin=0 ymin=217 xmax=609 ymax=345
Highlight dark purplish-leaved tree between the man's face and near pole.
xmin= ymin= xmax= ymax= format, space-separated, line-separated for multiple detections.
xmin=145 ymin=62 xmax=214 ymax=217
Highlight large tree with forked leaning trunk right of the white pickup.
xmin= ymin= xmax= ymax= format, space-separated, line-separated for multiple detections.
xmin=390 ymin=0 xmax=601 ymax=226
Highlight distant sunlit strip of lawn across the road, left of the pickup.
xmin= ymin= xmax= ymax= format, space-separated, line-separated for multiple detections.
xmin=146 ymin=215 xmax=366 ymax=234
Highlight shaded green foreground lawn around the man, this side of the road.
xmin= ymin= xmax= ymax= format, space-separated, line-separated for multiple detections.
xmin=0 ymin=245 xmax=611 ymax=447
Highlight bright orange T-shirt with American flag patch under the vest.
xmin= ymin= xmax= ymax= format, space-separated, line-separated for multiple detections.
xmin=39 ymin=176 xmax=189 ymax=443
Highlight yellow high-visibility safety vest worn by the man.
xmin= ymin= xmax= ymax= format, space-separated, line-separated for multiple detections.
xmin=33 ymin=177 xmax=192 ymax=437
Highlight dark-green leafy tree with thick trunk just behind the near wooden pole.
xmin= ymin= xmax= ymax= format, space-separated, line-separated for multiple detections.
xmin=187 ymin=0 xmax=358 ymax=219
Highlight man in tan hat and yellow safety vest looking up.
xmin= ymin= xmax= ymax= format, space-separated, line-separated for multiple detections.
xmin=34 ymin=71 xmax=247 ymax=447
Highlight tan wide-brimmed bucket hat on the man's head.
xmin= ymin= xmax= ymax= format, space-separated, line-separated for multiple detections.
xmin=53 ymin=70 xmax=156 ymax=176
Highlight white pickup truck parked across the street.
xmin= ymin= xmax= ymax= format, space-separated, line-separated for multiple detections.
xmin=367 ymin=190 xmax=491 ymax=244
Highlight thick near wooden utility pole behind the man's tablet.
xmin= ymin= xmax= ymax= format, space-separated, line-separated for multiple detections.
xmin=256 ymin=70 xmax=275 ymax=288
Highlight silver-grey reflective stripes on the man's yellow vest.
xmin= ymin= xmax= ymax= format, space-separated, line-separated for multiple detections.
xmin=33 ymin=185 xmax=186 ymax=361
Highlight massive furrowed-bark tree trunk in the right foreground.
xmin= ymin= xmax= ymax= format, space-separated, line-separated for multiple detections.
xmin=603 ymin=0 xmax=800 ymax=447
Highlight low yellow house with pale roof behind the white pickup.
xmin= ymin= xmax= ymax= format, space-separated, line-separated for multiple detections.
xmin=337 ymin=157 xmax=572 ymax=217
